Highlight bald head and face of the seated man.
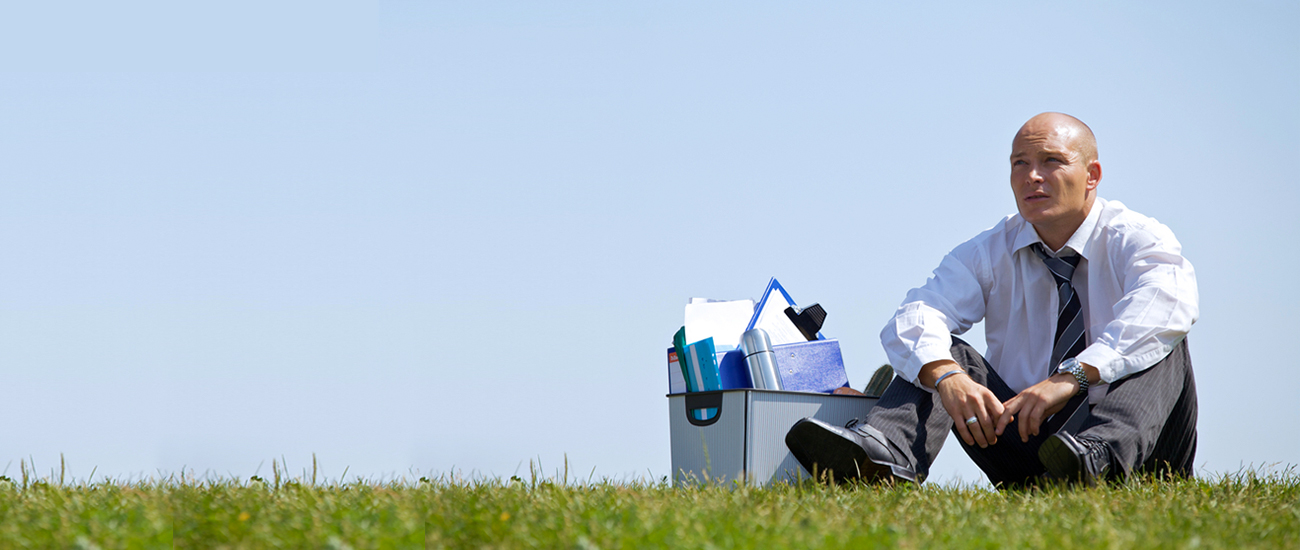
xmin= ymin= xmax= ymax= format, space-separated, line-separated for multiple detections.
xmin=1011 ymin=121 xmax=1101 ymax=235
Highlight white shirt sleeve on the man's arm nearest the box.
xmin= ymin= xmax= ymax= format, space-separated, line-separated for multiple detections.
xmin=880 ymin=243 xmax=987 ymax=391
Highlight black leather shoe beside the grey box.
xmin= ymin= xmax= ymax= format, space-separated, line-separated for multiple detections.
xmin=785 ymin=419 xmax=917 ymax=482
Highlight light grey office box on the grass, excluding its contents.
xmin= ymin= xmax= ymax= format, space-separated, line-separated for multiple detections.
xmin=668 ymin=389 xmax=876 ymax=486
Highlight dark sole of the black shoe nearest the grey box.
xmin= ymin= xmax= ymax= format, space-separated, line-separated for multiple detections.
xmin=785 ymin=420 xmax=893 ymax=484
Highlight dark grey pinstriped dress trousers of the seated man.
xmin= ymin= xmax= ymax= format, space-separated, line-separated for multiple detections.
xmin=867 ymin=337 xmax=1196 ymax=486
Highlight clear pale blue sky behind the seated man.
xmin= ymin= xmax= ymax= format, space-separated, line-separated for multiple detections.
xmin=0 ymin=1 xmax=1300 ymax=481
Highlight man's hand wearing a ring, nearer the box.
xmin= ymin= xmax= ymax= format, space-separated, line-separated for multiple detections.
xmin=920 ymin=360 xmax=1004 ymax=449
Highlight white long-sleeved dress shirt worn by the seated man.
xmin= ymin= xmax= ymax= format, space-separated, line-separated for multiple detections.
xmin=880 ymin=198 xmax=1199 ymax=403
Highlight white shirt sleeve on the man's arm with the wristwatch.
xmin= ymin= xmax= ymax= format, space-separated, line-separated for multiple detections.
xmin=1079 ymin=224 xmax=1200 ymax=382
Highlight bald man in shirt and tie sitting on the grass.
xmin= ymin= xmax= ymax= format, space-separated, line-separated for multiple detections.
xmin=785 ymin=113 xmax=1197 ymax=486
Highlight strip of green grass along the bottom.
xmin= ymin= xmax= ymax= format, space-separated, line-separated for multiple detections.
xmin=0 ymin=462 xmax=1300 ymax=550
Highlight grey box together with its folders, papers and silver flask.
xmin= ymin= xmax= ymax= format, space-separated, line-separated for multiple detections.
xmin=668 ymin=278 xmax=876 ymax=485
